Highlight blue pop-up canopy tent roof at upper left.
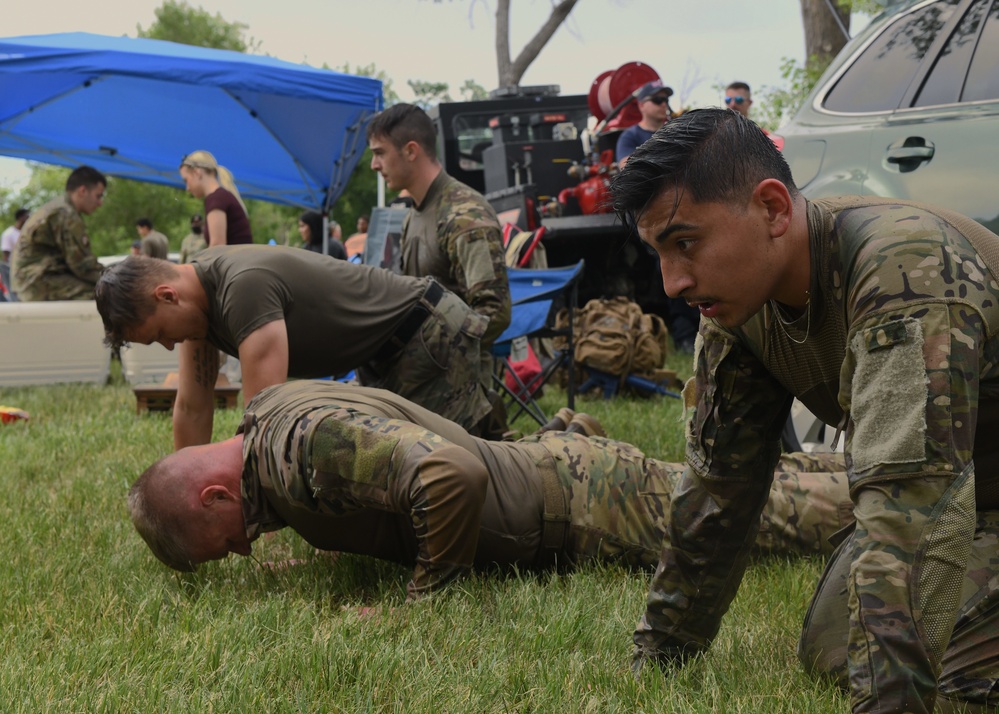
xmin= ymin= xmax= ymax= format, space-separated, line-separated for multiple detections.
xmin=0 ymin=32 xmax=382 ymax=210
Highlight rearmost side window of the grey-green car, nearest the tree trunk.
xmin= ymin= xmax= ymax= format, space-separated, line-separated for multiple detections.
xmin=823 ymin=0 xmax=960 ymax=112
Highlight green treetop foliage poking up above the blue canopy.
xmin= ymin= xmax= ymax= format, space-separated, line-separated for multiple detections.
xmin=135 ymin=0 xmax=260 ymax=52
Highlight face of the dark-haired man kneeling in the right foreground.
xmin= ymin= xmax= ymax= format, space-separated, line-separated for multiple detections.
xmin=638 ymin=188 xmax=781 ymax=328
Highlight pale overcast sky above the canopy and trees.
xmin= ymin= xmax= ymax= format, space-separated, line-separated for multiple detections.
xmin=0 ymin=0 xmax=876 ymax=185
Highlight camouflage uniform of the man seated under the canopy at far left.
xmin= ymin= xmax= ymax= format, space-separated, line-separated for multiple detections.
xmin=11 ymin=194 xmax=103 ymax=302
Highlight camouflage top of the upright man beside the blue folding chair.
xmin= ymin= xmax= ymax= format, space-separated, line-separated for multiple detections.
xmin=400 ymin=171 xmax=510 ymax=351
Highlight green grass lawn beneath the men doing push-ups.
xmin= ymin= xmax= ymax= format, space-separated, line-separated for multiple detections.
xmin=0 ymin=362 xmax=848 ymax=714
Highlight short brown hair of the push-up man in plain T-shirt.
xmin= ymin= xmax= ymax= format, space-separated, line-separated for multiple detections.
xmin=94 ymin=255 xmax=177 ymax=349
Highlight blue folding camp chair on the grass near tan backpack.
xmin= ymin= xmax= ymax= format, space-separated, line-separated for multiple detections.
xmin=493 ymin=260 xmax=584 ymax=425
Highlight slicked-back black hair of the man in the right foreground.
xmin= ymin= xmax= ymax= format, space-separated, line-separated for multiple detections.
xmin=611 ymin=107 xmax=798 ymax=227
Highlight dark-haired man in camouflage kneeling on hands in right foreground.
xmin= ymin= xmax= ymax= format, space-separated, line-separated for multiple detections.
xmin=613 ymin=109 xmax=999 ymax=712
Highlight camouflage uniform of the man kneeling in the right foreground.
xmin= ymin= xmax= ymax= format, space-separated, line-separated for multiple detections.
xmin=635 ymin=197 xmax=999 ymax=712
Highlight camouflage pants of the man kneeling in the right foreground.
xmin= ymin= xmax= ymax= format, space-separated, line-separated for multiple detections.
xmin=798 ymin=454 xmax=999 ymax=712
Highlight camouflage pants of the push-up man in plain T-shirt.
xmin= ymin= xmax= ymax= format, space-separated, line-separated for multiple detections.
xmin=357 ymin=292 xmax=492 ymax=433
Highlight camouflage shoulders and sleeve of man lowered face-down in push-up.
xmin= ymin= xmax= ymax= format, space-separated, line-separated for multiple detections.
xmin=241 ymin=381 xmax=488 ymax=598
